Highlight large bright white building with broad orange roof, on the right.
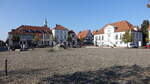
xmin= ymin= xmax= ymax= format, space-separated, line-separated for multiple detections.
xmin=94 ymin=21 xmax=142 ymax=47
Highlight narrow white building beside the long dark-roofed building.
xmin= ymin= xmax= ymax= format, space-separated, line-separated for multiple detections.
xmin=52 ymin=24 xmax=69 ymax=43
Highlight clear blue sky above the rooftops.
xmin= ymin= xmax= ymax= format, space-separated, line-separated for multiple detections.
xmin=0 ymin=0 xmax=150 ymax=40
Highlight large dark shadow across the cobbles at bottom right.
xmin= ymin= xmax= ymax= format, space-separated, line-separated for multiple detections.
xmin=39 ymin=65 xmax=150 ymax=84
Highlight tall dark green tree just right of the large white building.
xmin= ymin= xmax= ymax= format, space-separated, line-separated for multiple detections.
xmin=141 ymin=20 xmax=149 ymax=45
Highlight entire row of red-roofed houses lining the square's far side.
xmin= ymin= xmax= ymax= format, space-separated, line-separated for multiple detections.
xmin=8 ymin=21 xmax=150 ymax=47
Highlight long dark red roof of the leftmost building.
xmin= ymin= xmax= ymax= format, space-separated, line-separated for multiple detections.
xmin=9 ymin=25 xmax=52 ymax=34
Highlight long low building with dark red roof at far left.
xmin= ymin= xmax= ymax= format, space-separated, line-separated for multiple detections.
xmin=8 ymin=25 xmax=52 ymax=48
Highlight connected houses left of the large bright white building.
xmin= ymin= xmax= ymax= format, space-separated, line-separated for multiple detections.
xmin=8 ymin=21 xmax=93 ymax=48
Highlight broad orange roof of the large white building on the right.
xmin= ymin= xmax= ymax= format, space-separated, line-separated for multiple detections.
xmin=97 ymin=21 xmax=134 ymax=34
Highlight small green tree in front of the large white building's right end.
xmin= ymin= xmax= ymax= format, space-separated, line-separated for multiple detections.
xmin=122 ymin=31 xmax=133 ymax=47
